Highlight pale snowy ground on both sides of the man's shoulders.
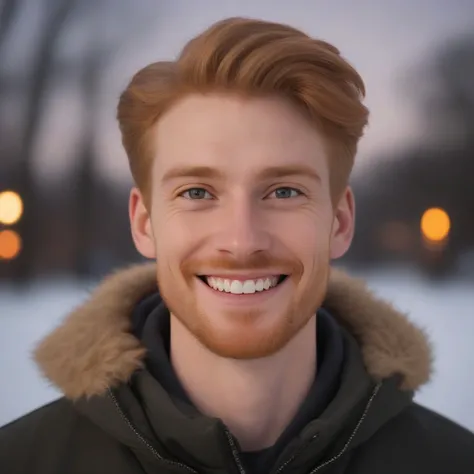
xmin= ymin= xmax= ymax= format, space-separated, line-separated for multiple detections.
xmin=0 ymin=271 xmax=474 ymax=431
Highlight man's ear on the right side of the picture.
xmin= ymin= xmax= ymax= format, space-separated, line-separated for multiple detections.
xmin=330 ymin=186 xmax=355 ymax=259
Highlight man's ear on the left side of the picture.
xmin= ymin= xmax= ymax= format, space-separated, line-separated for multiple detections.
xmin=128 ymin=187 xmax=156 ymax=259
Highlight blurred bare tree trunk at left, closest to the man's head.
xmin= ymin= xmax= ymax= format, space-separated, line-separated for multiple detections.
xmin=74 ymin=0 xmax=157 ymax=277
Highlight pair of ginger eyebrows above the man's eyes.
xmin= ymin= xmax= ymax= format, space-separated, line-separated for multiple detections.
xmin=161 ymin=165 xmax=321 ymax=183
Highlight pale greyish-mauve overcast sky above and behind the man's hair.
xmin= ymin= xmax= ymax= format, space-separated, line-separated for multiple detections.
xmin=5 ymin=0 xmax=474 ymax=181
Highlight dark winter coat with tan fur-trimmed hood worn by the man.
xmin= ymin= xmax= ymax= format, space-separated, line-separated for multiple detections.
xmin=0 ymin=265 xmax=474 ymax=474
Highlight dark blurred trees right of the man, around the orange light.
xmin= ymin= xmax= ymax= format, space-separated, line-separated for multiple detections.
xmin=351 ymin=36 xmax=474 ymax=276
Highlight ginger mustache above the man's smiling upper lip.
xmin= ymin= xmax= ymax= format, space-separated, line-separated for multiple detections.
xmin=181 ymin=253 xmax=303 ymax=276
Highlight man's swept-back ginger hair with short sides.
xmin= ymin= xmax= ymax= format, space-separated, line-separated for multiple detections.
xmin=117 ymin=18 xmax=369 ymax=204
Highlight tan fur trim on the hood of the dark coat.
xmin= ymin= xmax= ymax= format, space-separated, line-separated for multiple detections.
xmin=34 ymin=264 xmax=432 ymax=399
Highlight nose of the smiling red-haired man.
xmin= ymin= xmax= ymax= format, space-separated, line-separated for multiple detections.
xmin=216 ymin=199 xmax=271 ymax=260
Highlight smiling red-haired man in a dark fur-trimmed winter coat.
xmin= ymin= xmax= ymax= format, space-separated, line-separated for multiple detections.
xmin=0 ymin=18 xmax=474 ymax=474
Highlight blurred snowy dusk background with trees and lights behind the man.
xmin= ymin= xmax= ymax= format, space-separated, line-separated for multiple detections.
xmin=0 ymin=0 xmax=474 ymax=430
